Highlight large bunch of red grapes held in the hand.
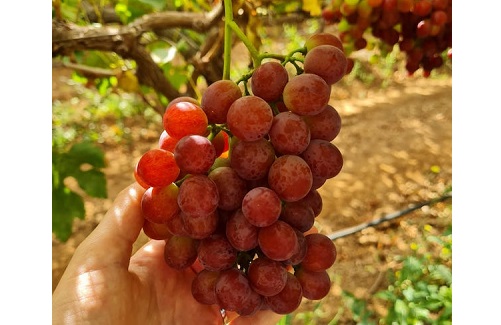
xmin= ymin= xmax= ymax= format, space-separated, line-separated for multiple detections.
xmin=134 ymin=33 xmax=349 ymax=316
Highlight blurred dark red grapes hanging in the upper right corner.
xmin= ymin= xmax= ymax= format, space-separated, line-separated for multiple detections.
xmin=322 ymin=0 xmax=452 ymax=77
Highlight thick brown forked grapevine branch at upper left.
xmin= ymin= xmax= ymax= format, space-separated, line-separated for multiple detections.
xmin=52 ymin=5 xmax=223 ymax=104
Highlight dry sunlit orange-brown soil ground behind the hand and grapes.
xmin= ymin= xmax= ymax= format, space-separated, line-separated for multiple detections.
xmin=52 ymin=60 xmax=452 ymax=324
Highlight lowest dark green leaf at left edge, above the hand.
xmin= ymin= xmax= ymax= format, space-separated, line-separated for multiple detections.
xmin=52 ymin=188 xmax=85 ymax=242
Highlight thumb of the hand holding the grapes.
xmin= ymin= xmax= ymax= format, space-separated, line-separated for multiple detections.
xmin=69 ymin=183 xmax=145 ymax=268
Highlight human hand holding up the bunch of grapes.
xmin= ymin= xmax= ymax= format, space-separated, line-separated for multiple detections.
xmin=52 ymin=183 xmax=282 ymax=325
